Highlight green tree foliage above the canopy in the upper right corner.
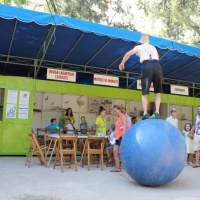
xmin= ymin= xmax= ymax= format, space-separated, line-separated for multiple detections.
xmin=137 ymin=0 xmax=200 ymax=46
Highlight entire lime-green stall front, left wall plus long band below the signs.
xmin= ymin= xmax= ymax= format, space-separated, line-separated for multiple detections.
xmin=0 ymin=76 xmax=200 ymax=155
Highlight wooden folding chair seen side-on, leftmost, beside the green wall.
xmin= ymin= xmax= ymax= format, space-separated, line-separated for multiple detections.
xmin=25 ymin=133 xmax=48 ymax=168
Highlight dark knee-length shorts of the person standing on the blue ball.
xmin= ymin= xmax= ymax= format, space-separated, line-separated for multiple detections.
xmin=141 ymin=60 xmax=162 ymax=95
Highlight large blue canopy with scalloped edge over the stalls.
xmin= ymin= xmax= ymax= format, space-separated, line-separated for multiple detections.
xmin=0 ymin=5 xmax=200 ymax=96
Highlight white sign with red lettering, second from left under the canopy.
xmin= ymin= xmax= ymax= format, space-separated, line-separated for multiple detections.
xmin=93 ymin=74 xmax=119 ymax=87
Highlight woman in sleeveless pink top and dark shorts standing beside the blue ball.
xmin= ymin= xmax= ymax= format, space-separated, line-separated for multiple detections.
xmin=110 ymin=105 xmax=126 ymax=172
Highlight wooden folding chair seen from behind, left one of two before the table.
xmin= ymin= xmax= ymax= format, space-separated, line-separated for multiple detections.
xmin=54 ymin=135 xmax=77 ymax=172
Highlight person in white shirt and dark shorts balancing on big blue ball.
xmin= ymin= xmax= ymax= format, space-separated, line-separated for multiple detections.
xmin=119 ymin=34 xmax=162 ymax=119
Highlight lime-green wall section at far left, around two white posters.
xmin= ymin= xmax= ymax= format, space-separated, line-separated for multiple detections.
xmin=0 ymin=76 xmax=34 ymax=155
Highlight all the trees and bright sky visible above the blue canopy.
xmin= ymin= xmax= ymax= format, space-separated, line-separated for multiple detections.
xmin=0 ymin=0 xmax=200 ymax=47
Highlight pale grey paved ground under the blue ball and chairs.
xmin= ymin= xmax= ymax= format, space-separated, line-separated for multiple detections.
xmin=0 ymin=157 xmax=200 ymax=200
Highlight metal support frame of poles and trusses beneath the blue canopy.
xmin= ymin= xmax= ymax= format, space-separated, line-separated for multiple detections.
xmin=0 ymin=16 xmax=200 ymax=96
